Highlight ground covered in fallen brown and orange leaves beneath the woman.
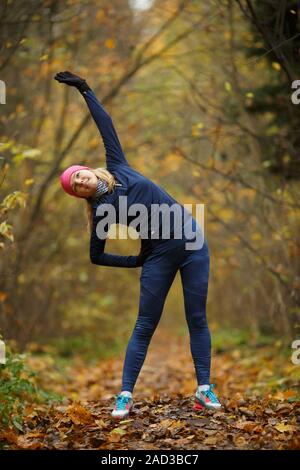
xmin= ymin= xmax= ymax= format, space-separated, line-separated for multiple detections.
xmin=1 ymin=332 xmax=300 ymax=450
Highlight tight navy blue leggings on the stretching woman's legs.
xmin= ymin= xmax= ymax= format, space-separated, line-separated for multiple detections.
xmin=122 ymin=235 xmax=211 ymax=392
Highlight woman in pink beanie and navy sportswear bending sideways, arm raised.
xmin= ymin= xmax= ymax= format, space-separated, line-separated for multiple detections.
xmin=54 ymin=71 xmax=221 ymax=418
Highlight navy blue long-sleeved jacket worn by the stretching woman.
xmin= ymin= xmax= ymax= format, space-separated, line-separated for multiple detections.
xmin=82 ymin=90 xmax=197 ymax=268
